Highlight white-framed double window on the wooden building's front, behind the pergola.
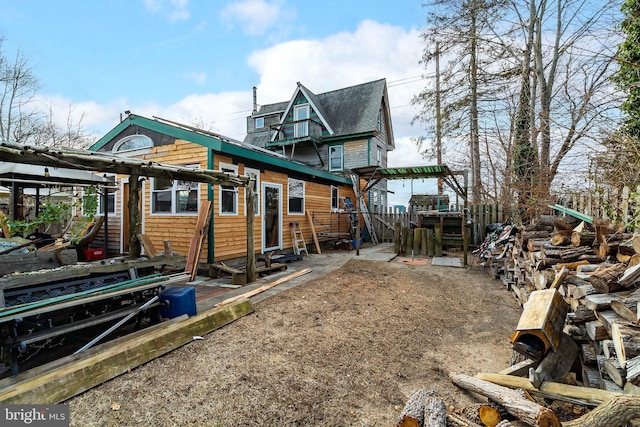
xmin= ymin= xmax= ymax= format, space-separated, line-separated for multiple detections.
xmin=151 ymin=165 xmax=200 ymax=214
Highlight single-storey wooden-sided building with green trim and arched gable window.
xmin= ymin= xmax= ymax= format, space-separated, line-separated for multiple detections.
xmin=90 ymin=114 xmax=354 ymax=263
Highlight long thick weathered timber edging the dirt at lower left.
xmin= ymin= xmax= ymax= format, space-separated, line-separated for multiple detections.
xmin=0 ymin=299 xmax=254 ymax=404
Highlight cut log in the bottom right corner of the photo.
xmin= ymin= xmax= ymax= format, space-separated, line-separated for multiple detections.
xmin=562 ymin=395 xmax=640 ymax=427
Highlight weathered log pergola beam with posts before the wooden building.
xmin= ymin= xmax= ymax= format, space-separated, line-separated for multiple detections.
xmin=0 ymin=141 xmax=255 ymax=281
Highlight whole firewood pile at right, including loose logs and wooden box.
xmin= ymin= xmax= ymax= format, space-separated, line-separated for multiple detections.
xmin=398 ymin=216 xmax=640 ymax=427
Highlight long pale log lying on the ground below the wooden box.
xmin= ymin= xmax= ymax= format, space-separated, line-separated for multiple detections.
xmin=449 ymin=372 xmax=561 ymax=427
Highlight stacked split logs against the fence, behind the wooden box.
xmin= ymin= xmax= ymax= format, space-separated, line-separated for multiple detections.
xmin=478 ymin=220 xmax=640 ymax=398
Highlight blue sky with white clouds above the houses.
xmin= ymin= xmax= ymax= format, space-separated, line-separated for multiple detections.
xmin=0 ymin=0 xmax=436 ymax=205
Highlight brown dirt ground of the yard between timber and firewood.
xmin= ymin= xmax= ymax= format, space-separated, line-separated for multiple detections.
xmin=67 ymin=259 xmax=521 ymax=426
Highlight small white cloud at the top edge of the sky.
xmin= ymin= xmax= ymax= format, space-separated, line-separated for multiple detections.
xmin=221 ymin=0 xmax=295 ymax=36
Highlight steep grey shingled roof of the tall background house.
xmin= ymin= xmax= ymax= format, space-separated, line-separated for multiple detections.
xmin=254 ymin=79 xmax=393 ymax=146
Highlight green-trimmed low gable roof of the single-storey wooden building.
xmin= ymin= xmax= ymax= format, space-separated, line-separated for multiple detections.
xmin=89 ymin=114 xmax=351 ymax=185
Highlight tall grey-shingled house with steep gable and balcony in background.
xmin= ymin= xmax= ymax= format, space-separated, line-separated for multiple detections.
xmin=244 ymin=79 xmax=395 ymax=211
